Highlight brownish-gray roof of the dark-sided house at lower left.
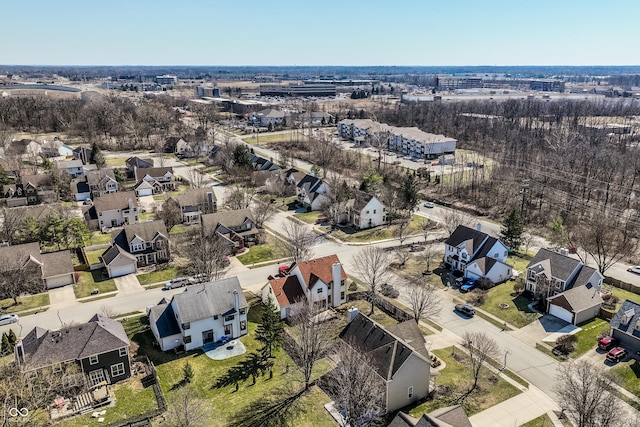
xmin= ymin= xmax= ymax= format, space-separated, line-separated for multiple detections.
xmin=22 ymin=314 xmax=130 ymax=369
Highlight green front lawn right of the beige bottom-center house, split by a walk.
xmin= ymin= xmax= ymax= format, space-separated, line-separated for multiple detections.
xmin=409 ymin=347 xmax=520 ymax=418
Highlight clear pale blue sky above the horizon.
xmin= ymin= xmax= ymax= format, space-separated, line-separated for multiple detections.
xmin=0 ymin=0 xmax=640 ymax=65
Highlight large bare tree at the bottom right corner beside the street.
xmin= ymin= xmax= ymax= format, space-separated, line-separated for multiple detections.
xmin=554 ymin=360 xmax=621 ymax=427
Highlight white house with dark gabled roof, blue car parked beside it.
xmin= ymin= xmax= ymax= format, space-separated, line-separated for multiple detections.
xmin=444 ymin=225 xmax=513 ymax=283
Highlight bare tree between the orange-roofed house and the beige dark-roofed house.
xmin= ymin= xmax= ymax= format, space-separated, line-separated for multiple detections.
xmin=285 ymin=299 xmax=332 ymax=390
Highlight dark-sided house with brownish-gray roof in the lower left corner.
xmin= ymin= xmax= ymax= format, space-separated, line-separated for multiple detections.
xmin=14 ymin=314 xmax=131 ymax=385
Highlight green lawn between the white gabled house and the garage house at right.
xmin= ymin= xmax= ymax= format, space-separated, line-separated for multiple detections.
xmin=461 ymin=280 xmax=540 ymax=328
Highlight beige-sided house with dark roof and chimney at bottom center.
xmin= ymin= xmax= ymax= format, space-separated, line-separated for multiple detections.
xmin=340 ymin=309 xmax=438 ymax=413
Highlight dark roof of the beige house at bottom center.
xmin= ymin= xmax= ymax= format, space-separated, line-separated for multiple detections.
xmin=340 ymin=313 xmax=429 ymax=380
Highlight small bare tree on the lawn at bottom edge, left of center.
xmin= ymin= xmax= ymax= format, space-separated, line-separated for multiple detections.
xmin=166 ymin=386 xmax=210 ymax=427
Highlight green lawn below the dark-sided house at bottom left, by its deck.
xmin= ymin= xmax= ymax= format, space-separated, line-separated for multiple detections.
xmin=56 ymin=380 xmax=158 ymax=427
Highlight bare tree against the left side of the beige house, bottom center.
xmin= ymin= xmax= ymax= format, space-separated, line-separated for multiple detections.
xmin=327 ymin=342 xmax=385 ymax=427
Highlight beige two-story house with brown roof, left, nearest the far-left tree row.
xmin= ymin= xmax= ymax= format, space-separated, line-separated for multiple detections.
xmin=83 ymin=191 xmax=140 ymax=230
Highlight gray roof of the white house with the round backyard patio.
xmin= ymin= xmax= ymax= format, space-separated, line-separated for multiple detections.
xmin=173 ymin=276 xmax=247 ymax=322
